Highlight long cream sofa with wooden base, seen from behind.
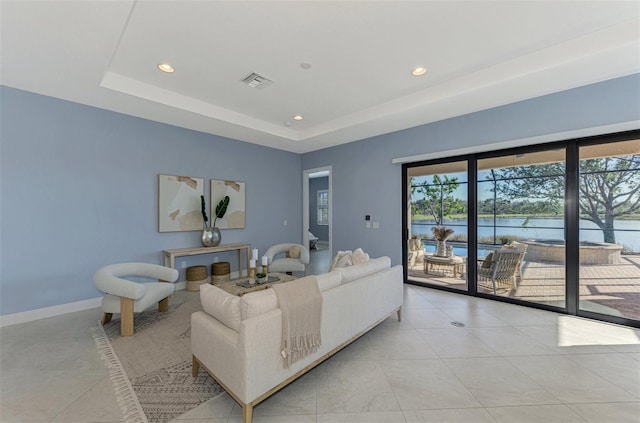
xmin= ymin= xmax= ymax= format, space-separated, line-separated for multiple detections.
xmin=191 ymin=257 xmax=403 ymax=423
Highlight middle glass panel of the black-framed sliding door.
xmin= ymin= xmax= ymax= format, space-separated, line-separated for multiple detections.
xmin=476 ymin=148 xmax=566 ymax=307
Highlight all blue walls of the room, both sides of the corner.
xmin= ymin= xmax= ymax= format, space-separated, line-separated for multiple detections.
xmin=0 ymin=74 xmax=640 ymax=315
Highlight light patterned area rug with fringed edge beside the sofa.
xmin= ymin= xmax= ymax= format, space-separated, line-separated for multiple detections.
xmin=94 ymin=291 xmax=223 ymax=423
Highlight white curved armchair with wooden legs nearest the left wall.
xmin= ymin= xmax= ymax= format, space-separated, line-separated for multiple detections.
xmin=93 ymin=263 xmax=178 ymax=336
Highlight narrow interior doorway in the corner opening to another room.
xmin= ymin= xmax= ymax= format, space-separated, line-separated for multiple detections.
xmin=302 ymin=166 xmax=333 ymax=274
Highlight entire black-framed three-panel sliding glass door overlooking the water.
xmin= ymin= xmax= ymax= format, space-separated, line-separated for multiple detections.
xmin=403 ymin=131 xmax=640 ymax=327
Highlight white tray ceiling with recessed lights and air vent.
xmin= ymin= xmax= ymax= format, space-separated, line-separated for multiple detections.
xmin=0 ymin=0 xmax=640 ymax=153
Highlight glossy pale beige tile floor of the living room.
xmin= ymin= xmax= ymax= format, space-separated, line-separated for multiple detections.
xmin=0 ymin=268 xmax=640 ymax=423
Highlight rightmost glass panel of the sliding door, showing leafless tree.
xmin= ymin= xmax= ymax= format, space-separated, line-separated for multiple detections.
xmin=579 ymin=140 xmax=640 ymax=320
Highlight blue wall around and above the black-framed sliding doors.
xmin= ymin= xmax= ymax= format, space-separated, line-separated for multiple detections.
xmin=302 ymin=74 xmax=640 ymax=264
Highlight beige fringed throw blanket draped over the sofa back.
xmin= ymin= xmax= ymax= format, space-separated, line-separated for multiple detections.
xmin=272 ymin=276 xmax=322 ymax=368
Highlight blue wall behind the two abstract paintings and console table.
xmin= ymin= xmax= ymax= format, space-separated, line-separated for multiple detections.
xmin=0 ymin=87 xmax=302 ymax=315
